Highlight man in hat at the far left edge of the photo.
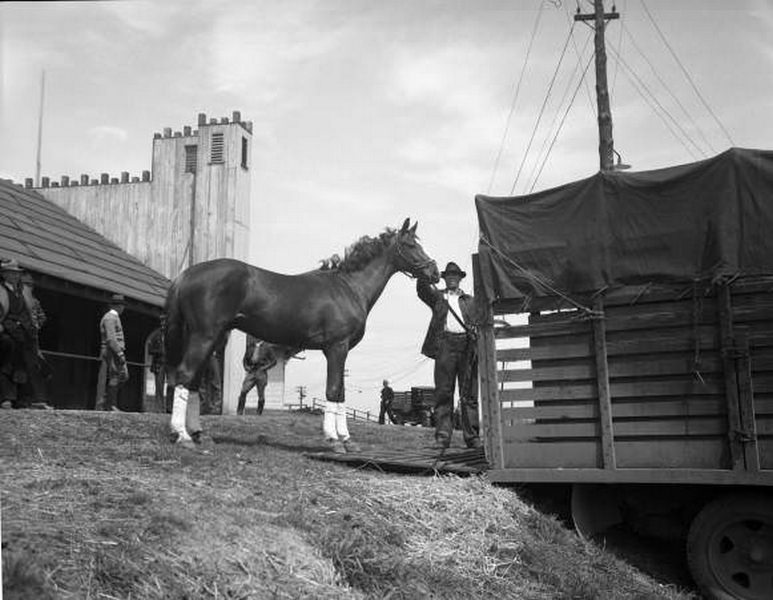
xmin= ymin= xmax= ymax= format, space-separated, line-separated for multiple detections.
xmin=0 ymin=259 xmax=37 ymax=408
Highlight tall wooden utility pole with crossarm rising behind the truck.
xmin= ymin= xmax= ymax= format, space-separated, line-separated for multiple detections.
xmin=574 ymin=0 xmax=620 ymax=171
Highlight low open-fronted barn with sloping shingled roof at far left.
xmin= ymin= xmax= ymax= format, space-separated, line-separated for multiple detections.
xmin=0 ymin=180 xmax=169 ymax=411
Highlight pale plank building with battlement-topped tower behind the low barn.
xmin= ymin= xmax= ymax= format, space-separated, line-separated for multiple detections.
xmin=25 ymin=111 xmax=285 ymax=414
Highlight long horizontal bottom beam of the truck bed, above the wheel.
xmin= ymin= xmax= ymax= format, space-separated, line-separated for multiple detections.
xmin=486 ymin=468 xmax=773 ymax=487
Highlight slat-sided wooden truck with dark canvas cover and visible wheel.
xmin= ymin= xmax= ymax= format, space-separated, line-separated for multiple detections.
xmin=473 ymin=150 xmax=773 ymax=600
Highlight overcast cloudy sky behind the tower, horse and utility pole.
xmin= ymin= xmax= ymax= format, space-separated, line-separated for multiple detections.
xmin=0 ymin=0 xmax=773 ymax=409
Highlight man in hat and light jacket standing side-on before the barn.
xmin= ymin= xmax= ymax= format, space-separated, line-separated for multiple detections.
xmin=94 ymin=294 xmax=129 ymax=411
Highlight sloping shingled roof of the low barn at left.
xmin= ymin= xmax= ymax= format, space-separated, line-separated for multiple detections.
xmin=0 ymin=180 xmax=170 ymax=307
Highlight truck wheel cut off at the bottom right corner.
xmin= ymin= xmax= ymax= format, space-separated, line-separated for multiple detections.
xmin=687 ymin=492 xmax=773 ymax=600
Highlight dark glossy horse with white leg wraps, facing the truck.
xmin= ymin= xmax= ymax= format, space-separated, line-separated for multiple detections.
xmin=164 ymin=219 xmax=440 ymax=453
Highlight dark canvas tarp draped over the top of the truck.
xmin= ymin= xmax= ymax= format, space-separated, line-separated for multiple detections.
xmin=475 ymin=148 xmax=773 ymax=299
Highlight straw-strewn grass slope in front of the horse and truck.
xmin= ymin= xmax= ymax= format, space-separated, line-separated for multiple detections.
xmin=0 ymin=411 xmax=688 ymax=600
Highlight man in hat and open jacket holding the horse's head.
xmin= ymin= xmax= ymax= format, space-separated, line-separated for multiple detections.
xmin=416 ymin=262 xmax=481 ymax=451
